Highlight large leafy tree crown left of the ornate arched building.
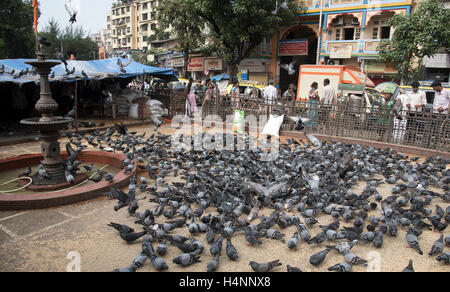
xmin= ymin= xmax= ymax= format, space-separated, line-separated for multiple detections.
xmin=184 ymin=0 xmax=303 ymax=76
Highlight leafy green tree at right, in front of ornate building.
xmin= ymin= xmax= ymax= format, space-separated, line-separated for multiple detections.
xmin=378 ymin=0 xmax=450 ymax=83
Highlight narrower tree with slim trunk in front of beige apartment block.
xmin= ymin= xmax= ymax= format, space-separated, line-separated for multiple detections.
xmin=157 ymin=0 xmax=206 ymax=78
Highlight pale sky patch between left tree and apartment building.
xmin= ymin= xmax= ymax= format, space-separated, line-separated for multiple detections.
xmin=38 ymin=0 xmax=116 ymax=33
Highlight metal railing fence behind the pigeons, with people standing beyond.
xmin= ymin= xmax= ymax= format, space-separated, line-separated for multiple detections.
xmin=163 ymin=92 xmax=450 ymax=152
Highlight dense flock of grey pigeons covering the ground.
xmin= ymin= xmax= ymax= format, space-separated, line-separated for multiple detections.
xmin=54 ymin=125 xmax=450 ymax=272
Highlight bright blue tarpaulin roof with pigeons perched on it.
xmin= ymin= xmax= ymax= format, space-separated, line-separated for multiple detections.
xmin=0 ymin=58 xmax=178 ymax=85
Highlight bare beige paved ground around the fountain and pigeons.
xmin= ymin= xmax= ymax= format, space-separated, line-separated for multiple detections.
xmin=0 ymin=122 xmax=450 ymax=272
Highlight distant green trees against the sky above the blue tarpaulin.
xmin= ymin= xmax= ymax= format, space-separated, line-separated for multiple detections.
xmin=39 ymin=19 xmax=98 ymax=60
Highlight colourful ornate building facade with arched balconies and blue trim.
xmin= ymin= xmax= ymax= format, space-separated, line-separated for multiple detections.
xmin=264 ymin=0 xmax=414 ymax=90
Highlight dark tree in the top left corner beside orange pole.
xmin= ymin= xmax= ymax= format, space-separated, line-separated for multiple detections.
xmin=0 ymin=0 xmax=36 ymax=59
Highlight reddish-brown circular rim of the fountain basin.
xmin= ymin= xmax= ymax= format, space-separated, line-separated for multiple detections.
xmin=0 ymin=151 xmax=136 ymax=211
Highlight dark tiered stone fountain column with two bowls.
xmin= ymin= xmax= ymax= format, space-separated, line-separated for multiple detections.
xmin=21 ymin=52 xmax=73 ymax=186
